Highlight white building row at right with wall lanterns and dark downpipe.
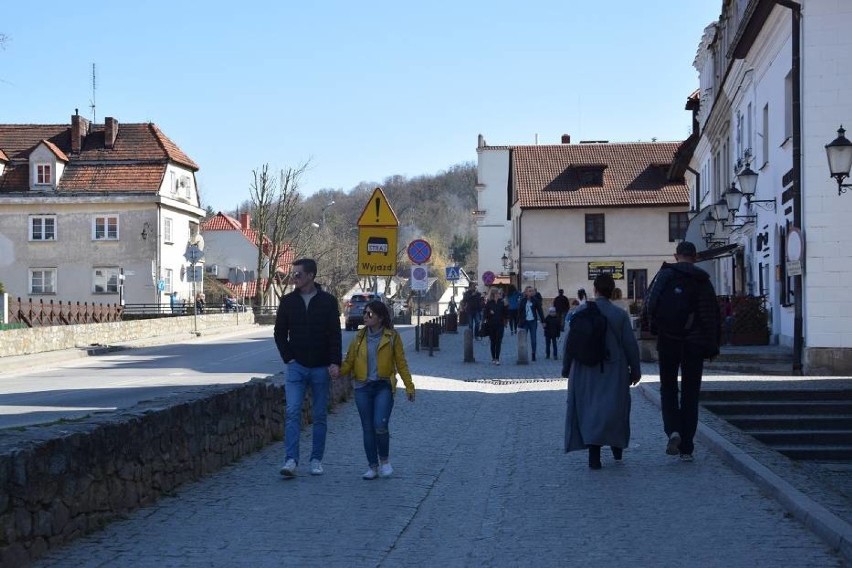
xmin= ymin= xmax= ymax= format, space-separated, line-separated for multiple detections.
xmin=686 ymin=0 xmax=852 ymax=374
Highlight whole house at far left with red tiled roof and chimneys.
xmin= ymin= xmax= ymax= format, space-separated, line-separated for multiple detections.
xmin=0 ymin=114 xmax=204 ymax=305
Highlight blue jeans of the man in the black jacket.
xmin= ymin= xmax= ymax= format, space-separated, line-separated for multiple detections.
xmin=284 ymin=361 xmax=329 ymax=463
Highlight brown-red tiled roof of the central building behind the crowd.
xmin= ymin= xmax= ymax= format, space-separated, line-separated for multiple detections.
xmin=509 ymin=142 xmax=689 ymax=209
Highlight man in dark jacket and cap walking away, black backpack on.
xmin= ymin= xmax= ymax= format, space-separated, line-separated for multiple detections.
xmin=645 ymin=241 xmax=721 ymax=461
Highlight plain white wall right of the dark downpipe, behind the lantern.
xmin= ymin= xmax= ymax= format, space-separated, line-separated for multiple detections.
xmin=802 ymin=0 xmax=852 ymax=348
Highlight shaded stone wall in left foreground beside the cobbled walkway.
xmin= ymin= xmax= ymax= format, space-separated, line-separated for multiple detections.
xmin=0 ymin=376 xmax=352 ymax=566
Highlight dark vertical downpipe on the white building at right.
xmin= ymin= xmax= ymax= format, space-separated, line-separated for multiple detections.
xmin=774 ymin=0 xmax=807 ymax=375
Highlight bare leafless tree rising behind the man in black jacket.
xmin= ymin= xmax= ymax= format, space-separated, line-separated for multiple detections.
xmin=249 ymin=162 xmax=308 ymax=306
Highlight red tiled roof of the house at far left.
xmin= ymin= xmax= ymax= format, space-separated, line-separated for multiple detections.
xmin=0 ymin=123 xmax=198 ymax=192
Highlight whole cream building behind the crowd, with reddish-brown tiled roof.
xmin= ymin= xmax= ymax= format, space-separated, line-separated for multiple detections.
xmin=477 ymin=135 xmax=689 ymax=302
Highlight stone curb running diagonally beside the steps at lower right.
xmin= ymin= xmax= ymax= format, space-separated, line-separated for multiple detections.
xmin=639 ymin=384 xmax=852 ymax=563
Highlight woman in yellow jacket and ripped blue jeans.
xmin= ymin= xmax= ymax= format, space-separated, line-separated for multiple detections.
xmin=340 ymin=300 xmax=414 ymax=479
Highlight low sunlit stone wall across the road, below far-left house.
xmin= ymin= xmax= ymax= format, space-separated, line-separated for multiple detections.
xmin=0 ymin=312 xmax=255 ymax=357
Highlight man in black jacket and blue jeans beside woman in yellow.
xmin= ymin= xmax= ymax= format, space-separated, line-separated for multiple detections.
xmin=275 ymin=258 xmax=342 ymax=478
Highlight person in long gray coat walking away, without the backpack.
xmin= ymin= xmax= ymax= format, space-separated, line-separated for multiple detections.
xmin=562 ymin=274 xmax=642 ymax=469
